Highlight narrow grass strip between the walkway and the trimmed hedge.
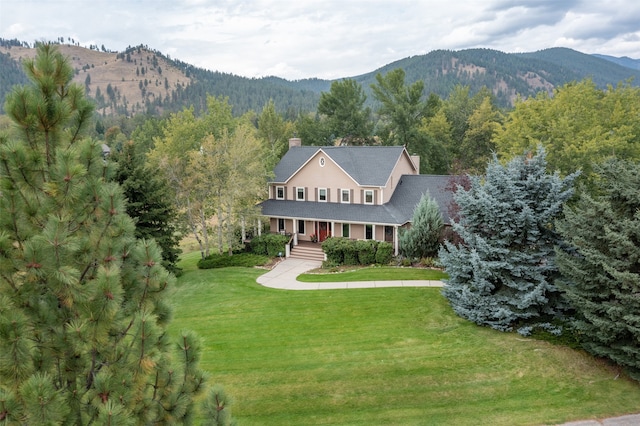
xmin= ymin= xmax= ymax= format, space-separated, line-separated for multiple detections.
xmin=298 ymin=266 xmax=447 ymax=283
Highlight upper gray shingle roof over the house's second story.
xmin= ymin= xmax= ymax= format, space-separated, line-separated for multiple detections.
xmin=274 ymin=146 xmax=404 ymax=186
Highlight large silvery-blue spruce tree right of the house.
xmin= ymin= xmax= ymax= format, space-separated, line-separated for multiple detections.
xmin=440 ymin=149 xmax=576 ymax=333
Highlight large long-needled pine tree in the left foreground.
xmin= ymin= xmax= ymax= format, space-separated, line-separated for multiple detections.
xmin=0 ymin=44 xmax=225 ymax=425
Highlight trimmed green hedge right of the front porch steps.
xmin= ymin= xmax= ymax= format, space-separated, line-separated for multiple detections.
xmin=322 ymin=237 xmax=393 ymax=266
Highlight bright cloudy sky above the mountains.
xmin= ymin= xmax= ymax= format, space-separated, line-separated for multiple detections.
xmin=0 ymin=0 xmax=640 ymax=80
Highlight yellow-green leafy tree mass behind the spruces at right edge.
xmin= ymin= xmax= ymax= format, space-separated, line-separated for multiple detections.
xmin=494 ymin=80 xmax=640 ymax=189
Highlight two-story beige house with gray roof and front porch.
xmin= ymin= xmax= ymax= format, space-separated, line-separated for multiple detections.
xmin=261 ymin=138 xmax=452 ymax=255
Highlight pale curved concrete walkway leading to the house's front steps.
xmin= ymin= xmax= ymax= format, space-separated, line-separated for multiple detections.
xmin=257 ymin=258 xmax=443 ymax=290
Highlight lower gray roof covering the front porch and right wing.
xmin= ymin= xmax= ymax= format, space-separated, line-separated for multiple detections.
xmin=260 ymin=175 xmax=452 ymax=225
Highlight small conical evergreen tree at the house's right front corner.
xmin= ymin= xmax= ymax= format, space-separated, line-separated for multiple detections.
xmin=399 ymin=193 xmax=443 ymax=258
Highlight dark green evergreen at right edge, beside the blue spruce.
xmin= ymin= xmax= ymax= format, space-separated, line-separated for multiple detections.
xmin=557 ymin=160 xmax=640 ymax=380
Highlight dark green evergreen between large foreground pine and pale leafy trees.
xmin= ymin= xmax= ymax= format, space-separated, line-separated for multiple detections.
xmin=114 ymin=142 xmax=181 ymax=273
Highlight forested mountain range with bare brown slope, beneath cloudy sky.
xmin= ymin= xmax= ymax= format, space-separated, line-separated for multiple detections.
xmin=0 ymin=39 xmax=640 ymax=118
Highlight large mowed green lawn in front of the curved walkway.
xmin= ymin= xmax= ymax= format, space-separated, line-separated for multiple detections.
xmin=171 ymin=251 xmax=640 ymax=425
